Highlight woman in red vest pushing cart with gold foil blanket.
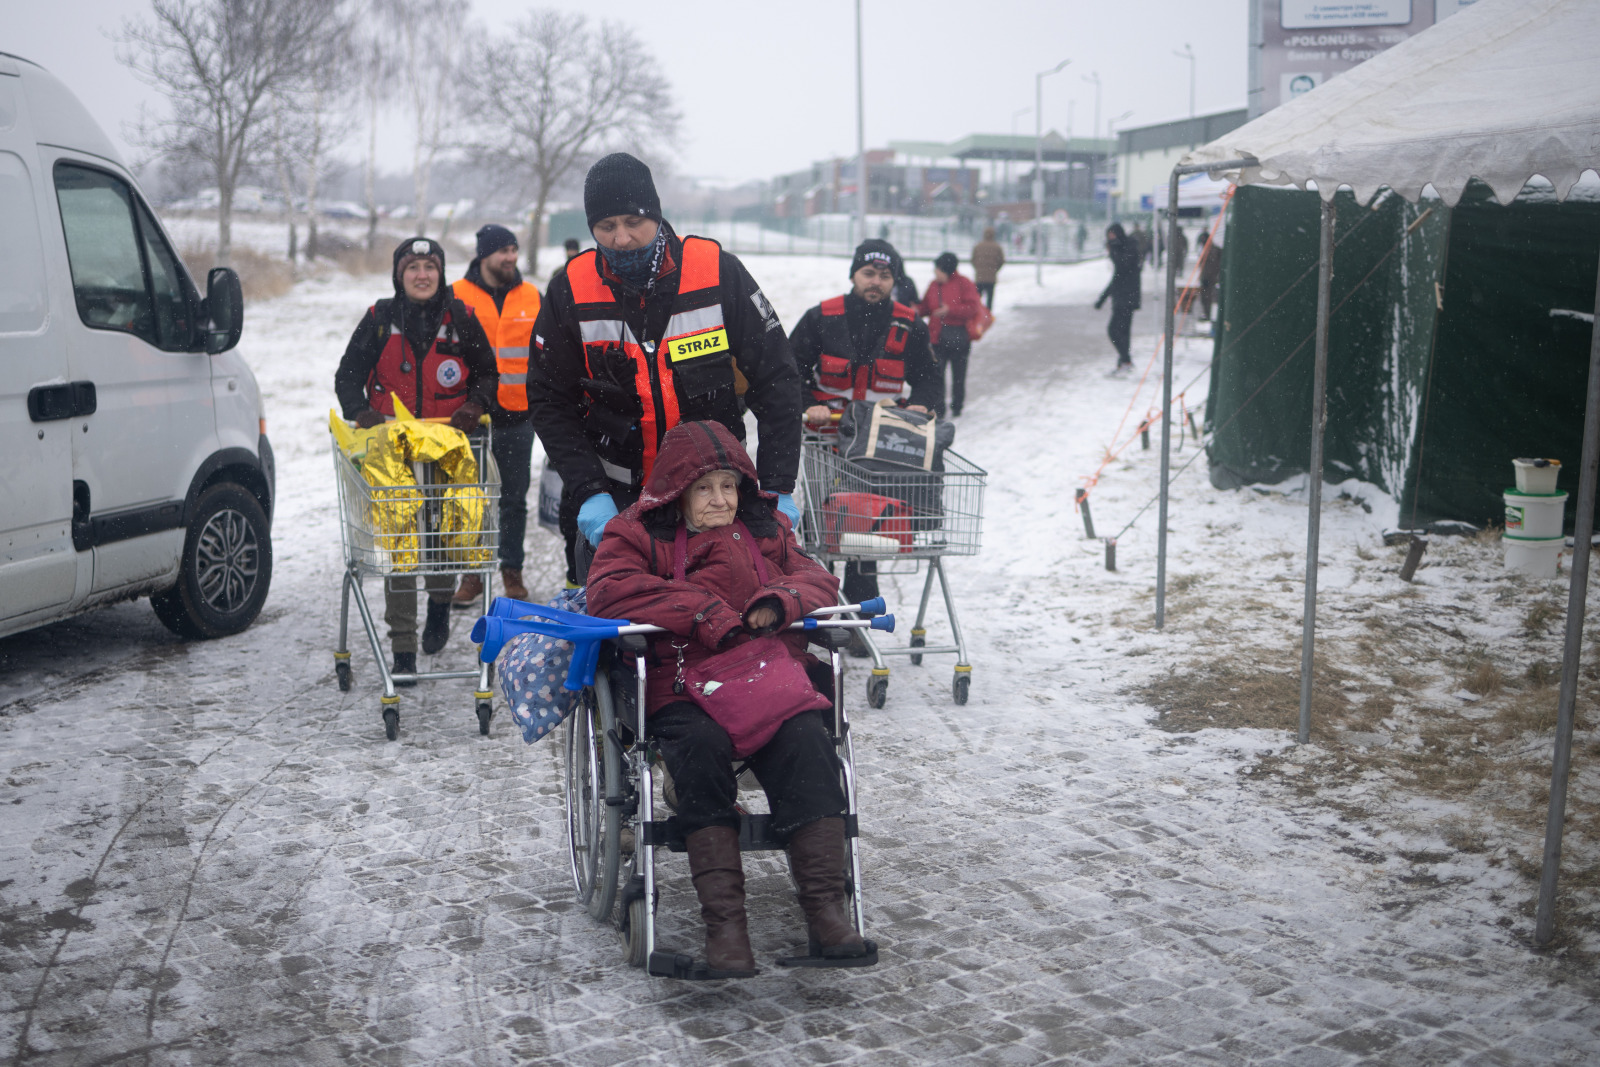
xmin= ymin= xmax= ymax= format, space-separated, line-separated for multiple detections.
xmin=333 ymin=237 xmax=499 ymax=685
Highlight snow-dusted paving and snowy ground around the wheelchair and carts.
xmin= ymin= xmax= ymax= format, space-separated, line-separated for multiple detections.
xmin=0 ymin=258 xmax=1600 ymax=1067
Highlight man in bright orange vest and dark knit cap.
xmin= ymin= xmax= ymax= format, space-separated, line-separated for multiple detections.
xmin=451 ymin=222 xmax=541 ymax=608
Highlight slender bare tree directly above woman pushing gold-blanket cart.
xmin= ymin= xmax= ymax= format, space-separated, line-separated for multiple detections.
xmin=389 ymin=0 xmax=469 ymax=234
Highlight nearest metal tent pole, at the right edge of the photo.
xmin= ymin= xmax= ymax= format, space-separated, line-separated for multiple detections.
xmin=1533 ymin=239 xmax=1600 ymax=945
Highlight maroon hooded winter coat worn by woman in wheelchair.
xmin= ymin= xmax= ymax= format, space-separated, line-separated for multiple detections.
xmin=587 ymin=422 xmax=838 ymax=713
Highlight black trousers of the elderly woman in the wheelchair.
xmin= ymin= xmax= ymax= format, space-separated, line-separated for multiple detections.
xmin=646 ymin=667 xmax=845 ymax=840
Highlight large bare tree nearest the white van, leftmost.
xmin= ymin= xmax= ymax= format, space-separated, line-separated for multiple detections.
xmin=118 ymin=0 xmax=336 ymax=264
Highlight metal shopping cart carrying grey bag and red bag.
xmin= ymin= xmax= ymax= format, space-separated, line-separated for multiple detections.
xmin=798 ymin=430 xmax=989 ymax=707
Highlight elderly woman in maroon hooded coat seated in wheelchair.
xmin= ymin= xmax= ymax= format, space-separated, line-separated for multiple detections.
xmin=589 ymin=422 xmax=867 ymax=977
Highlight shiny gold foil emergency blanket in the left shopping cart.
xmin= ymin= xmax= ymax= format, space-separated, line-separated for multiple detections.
xmin=328 ymin=398 xmax=494 ymax=574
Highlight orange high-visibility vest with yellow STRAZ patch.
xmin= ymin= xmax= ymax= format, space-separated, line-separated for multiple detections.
xmin=566 ymin=237 xmax=731 ymax=480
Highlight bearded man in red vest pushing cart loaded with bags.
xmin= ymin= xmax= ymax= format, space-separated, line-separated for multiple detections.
xmin=789 ymin=238 xmax=944 ymax=656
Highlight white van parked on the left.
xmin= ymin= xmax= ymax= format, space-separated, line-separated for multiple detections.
xmin=0 ymin=53 xmax=274 ymax=637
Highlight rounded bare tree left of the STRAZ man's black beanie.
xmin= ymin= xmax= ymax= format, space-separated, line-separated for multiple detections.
xmin=458 ymin=10 xmax=678 ymax=274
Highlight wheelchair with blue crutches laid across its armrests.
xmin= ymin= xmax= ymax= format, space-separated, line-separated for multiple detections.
xmin=474 ymin=600 xmax=894 ymax=981
